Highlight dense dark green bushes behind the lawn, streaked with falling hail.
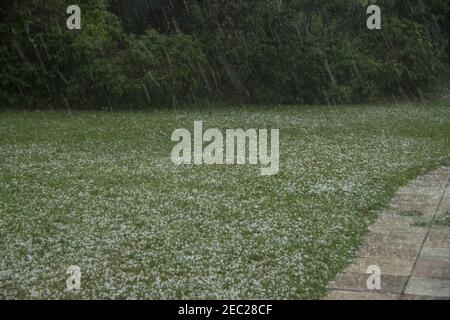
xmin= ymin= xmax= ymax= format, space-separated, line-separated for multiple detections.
xmin=0 ymin=0 xmax=450 ymax=108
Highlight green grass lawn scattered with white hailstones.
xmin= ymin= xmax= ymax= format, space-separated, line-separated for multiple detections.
xmin=0 ymin=102 xmax=450 ymax=299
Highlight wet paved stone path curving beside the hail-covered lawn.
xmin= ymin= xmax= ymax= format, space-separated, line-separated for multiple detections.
xmin=325 ymin=167 xmax=450 ymax=300
